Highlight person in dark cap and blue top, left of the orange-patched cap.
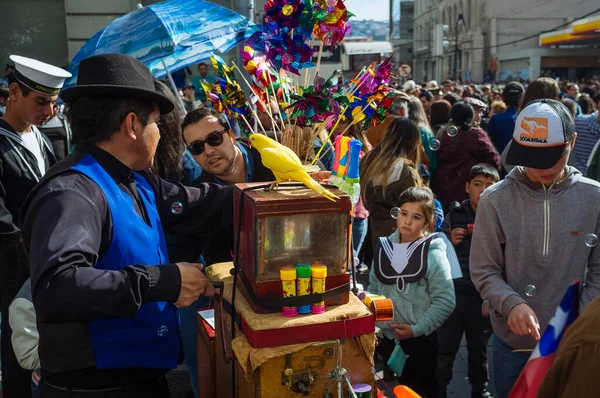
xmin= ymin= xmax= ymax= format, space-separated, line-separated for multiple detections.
xmin=488 ymin=82 xmax=525 ymax=153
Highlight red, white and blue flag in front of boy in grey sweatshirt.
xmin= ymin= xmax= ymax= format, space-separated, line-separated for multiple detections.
xmin=508 ymin=281 xmax=579 ymax=398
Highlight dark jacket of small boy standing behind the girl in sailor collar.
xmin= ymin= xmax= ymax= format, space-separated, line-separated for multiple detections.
xmin=442 ymin=199 xmax=479 ymax=296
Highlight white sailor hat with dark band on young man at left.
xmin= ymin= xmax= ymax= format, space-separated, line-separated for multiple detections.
xmin=9 ymin=55 xmax=71 ymax=95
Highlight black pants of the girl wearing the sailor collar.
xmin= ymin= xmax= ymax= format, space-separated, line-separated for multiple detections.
xmin=380 ymin=332 xmax=438 ymax=398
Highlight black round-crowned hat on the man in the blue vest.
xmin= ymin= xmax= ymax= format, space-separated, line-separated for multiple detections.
xmin=60 ymin=54 xmax=175 ymax=114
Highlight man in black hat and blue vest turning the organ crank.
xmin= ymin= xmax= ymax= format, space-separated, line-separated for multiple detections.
xmin=21 ymin=54 xmax=233 ymax=398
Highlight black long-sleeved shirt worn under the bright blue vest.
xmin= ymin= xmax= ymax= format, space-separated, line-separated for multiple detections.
xmin=21 ymin=145 xmax=233 ymax=388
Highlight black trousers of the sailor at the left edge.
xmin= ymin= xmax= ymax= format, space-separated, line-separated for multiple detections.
xmin=0 ymin=263 xmax=31 ymax=398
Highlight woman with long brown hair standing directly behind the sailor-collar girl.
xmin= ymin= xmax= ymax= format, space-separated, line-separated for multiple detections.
xmin=360 ymin=116 xmax=421 ymax=252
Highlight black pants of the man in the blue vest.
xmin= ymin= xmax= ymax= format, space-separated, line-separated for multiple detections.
xmin=35 ymin=377 xmax=171 ymax=398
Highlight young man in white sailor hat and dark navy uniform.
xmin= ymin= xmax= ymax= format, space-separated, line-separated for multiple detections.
xmin=0 ymin=55 xmax=71 ymax=398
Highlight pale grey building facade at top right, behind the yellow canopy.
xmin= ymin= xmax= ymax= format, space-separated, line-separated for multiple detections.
xmin=414 ymin=0 xmax=600 ymax=82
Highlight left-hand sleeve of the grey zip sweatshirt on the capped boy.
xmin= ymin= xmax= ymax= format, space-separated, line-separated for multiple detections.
xmin=469 ymin=192 xmax=525 ymax=316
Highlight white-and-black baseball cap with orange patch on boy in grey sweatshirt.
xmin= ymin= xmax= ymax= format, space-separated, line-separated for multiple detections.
xmin=506 ymin=99 xmax=575 ymax=169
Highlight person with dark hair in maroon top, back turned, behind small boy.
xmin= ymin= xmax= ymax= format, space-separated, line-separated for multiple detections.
xmin=432 ymin=101 xmax=500 ymax=211
